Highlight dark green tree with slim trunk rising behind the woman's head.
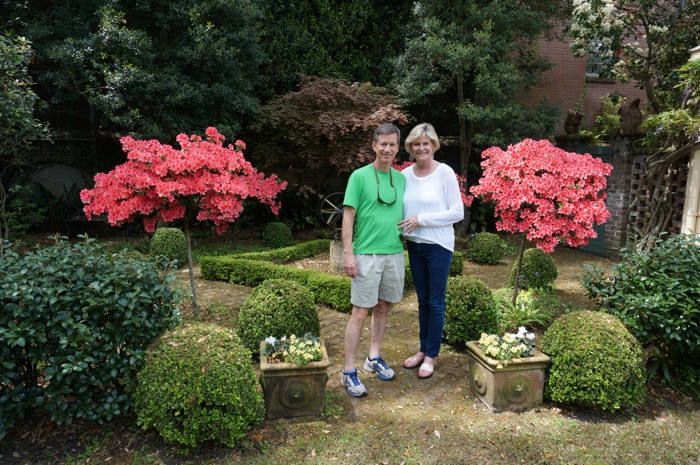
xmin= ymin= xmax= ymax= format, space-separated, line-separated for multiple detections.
xmin=394 ymin=0 xmax=561 ymax=175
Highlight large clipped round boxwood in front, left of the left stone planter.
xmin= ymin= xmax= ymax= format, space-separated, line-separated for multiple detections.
xmin=134 ymin=323 xmax=265 ymax=448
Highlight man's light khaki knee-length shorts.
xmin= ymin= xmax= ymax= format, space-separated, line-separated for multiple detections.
xmin=350 ymin=252 xmax=406 ymax=308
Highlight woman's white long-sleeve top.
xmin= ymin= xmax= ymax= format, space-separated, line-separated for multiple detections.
xmin=402 ymin=163 xmax=464 ymax=252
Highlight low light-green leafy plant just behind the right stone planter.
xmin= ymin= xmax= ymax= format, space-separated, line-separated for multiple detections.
xmin=493 ymin=287 xmax=561 ymax=334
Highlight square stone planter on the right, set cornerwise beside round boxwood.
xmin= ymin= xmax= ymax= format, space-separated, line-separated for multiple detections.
xmin=467 ymin=341 xmax=549 ymax=412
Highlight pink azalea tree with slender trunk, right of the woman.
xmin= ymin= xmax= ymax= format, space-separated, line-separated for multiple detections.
xmin=470 ymin=139 xmax=612 ymax=304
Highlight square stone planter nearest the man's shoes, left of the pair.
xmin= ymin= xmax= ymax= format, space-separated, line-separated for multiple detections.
xmin=260 ymin=340 xmax=330 ymax=419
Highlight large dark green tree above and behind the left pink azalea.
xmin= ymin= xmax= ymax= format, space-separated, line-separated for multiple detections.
xmin=25 ymin=0 xmax=263 ymax=139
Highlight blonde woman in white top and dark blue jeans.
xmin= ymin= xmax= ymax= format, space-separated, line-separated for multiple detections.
xmin=399 ymin=123 xmax=464 ymax=379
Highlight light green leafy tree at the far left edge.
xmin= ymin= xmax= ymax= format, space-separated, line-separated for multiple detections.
xmin=0 ymin=33 xmax=49 ymax=242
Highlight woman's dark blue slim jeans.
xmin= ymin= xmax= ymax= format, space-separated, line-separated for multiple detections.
xmin=406 ymin=241 xmax=452 ymax=358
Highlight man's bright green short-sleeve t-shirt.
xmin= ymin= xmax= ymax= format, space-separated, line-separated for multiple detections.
xmin=343 ymin=165 xmax=406 ymax=255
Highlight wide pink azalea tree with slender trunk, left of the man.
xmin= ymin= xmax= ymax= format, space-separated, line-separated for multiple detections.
xmin=80 ymin=127 xmax=287 ymax=314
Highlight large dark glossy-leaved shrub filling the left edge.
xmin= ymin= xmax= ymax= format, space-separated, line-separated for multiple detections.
xmin=0 ymin=241 xmax=181 ymax=437
